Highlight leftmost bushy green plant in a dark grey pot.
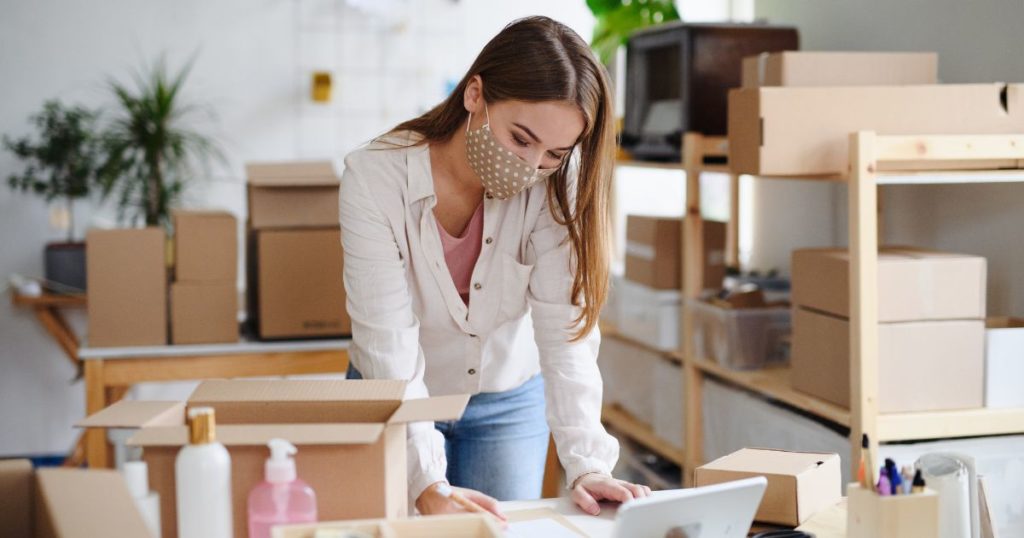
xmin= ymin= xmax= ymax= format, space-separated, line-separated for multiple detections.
xmin=3 ymin=100 xmax=100 ymax=291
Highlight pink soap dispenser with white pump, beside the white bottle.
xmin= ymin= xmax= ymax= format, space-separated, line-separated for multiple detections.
xmin=249 ymin=439 xmax=316 ymax=538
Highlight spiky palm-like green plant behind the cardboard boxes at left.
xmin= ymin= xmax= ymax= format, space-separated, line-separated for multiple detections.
xmin=97 ymin=59 xmax=222 ymax=227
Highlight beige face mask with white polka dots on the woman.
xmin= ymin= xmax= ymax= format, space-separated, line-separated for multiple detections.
xmin=466 ymin=105 xmax=558 ymax=200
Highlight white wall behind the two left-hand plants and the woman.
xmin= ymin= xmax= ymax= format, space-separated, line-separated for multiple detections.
xmin=0 ymin=0 xmax=593 ymax=456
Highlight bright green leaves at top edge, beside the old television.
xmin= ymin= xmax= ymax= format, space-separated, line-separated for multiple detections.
xmin=587 ymin=0 xmax=679 ymax=66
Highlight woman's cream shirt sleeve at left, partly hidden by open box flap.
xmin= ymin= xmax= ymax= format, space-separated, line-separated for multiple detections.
xmin=339 ymin=157 xmax=446 ymax=510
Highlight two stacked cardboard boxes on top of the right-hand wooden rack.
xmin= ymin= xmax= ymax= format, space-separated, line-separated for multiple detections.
xmin=729 ymin=52 xmax=1024 ymax=175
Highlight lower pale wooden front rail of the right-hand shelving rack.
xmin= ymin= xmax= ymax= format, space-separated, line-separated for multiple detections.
xmin=878 ymin=409 xmax=1024 ymax=442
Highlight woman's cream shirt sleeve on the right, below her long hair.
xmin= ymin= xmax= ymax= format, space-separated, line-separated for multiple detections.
xmin=529 ymin=196 xmax=618 ymax=487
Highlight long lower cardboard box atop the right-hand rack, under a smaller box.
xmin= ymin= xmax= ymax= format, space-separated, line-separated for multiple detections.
xmin=729 ymin=84 xmax=1024 ymax=175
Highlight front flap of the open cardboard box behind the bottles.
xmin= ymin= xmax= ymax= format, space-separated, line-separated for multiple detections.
xmin=128 ymin=424 xmax=384 ymax=447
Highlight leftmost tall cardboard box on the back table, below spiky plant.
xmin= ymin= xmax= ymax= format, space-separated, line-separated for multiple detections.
xmin=85 ymin=227 xmax=167 ymax=347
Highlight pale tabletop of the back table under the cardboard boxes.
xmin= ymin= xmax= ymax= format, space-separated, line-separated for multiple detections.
xmin=78 ymin=338 xmax=351 ymax=361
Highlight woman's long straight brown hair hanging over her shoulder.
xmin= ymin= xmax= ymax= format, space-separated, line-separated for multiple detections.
xmin=390 ymin=16 xmax=615 ymax=340
